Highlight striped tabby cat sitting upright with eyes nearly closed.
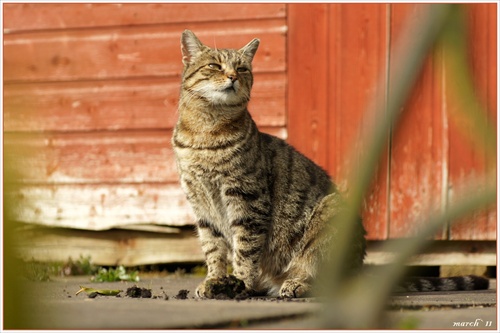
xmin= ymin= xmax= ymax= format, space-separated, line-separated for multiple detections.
xmin=172 ymin=30 xmax=488 ymax=297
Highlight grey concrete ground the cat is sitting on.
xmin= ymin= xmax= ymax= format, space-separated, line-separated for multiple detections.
xmin=7 ymin=276 xmax=497 ymax=330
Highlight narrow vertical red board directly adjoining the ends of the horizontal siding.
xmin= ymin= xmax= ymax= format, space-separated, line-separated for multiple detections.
xmin=287 ymin=4 xmax=329 ymax=168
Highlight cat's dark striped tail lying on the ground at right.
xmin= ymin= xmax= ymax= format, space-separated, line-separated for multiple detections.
xmin=395 ymin=275 xmax=490 ymax=292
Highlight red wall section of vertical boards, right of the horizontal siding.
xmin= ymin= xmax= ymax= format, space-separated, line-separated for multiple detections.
xmin=288 ymin=4 xmax=497 ymax=240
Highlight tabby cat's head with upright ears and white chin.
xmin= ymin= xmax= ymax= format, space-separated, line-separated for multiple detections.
xmin=181 ymin=30 xmax=259 ymax=106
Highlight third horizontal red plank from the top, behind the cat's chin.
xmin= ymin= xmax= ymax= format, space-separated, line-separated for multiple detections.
xmin=4 ymin=73 xmax=286 ymax=132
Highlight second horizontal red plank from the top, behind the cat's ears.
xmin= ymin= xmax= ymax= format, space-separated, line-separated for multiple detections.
xmin=3 ymin=19 xmax=286 ymax=82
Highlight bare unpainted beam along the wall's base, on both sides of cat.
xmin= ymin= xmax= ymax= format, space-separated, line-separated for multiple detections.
xmin=11 ymin=227 xmax=496 ymax=266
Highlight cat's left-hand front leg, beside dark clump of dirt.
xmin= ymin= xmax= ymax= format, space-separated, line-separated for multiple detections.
xmin=195 ymin=220 xmax=228 ymax=298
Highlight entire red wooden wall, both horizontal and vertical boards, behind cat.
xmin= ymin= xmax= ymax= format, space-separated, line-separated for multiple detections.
xmin=3 ymin=4 xmax=497 ymax=239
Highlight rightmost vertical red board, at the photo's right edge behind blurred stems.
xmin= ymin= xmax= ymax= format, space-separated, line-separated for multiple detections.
xmin=447 ymin=4 xmax=497 ymax=240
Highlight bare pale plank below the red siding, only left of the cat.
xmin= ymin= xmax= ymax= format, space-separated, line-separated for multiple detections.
xmin=16 ymin=228 xmax=204 ymax=266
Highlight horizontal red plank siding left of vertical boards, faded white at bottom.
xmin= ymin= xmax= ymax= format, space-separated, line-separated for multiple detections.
xmin=4 ymin=4 xmax=286 ymax=230
